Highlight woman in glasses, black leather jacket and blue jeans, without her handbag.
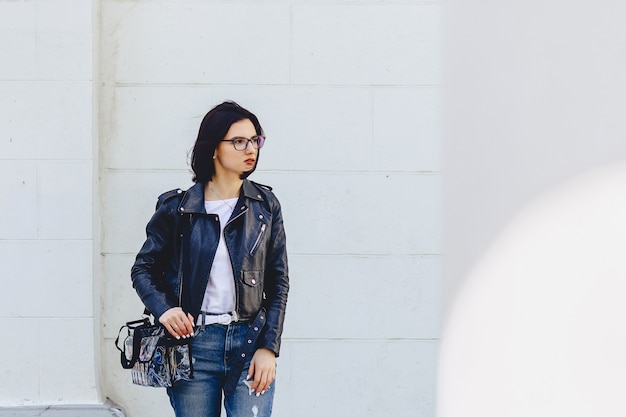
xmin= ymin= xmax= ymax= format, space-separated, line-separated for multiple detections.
xmin=131 ymin=102 xmax=289 ymax=417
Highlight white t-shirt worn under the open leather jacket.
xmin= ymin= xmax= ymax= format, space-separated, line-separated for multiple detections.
xmin=202 ymin=198 xmax=238 ymax=314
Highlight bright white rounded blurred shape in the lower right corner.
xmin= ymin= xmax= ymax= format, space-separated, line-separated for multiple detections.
xmin=438 ymin=161 xmax=626 ymax=417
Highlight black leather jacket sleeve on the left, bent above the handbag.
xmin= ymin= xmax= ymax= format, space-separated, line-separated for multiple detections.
xmin=131 ymin=197 xmax=178 ymax=319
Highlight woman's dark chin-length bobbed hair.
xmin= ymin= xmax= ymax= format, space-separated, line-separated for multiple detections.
xmin=191 ymin=101 xmax=263 ymax=183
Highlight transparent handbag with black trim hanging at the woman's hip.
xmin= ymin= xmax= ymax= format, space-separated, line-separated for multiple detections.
xmin=115 ymin=317 xmax=193 ymax=387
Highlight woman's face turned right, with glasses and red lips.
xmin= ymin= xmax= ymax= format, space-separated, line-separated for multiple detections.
xmin=214 ymin=119 xmax=259 ymax=177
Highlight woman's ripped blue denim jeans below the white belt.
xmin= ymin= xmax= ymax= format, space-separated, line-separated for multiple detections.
xmin=167 ymin=323 xmax=275 ymax=417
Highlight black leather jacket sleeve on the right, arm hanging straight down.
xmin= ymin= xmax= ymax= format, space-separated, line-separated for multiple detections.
xmin=258 ymin=197 xmax=289 ymax=357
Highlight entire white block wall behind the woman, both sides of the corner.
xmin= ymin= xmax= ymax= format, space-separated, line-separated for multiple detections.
xmin=0 ymin=0 xmax=441 ymax=417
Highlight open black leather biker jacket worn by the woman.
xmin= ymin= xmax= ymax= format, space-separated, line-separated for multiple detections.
xmin=131 ymin=180 xmax=289 ymax=356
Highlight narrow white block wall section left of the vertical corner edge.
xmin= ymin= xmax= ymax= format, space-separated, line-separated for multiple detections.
xmin=0 ymin=0 xmax=100 ymax=407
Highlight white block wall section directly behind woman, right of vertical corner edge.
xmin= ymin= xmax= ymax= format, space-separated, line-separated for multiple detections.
xmin=101 ymin=1 xmax=441 ymax=417
